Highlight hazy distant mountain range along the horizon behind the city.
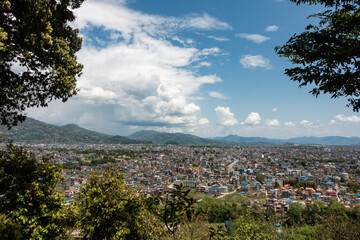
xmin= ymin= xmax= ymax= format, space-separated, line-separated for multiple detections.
xmin=0 ymin=118 xmax=360 ymax=145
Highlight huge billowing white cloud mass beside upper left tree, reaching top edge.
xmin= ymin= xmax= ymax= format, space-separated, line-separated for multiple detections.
xmin=45 ymin=0 xmax=231 ymax=127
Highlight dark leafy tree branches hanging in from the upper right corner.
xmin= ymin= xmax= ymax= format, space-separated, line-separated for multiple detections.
xmin=275 ymin=0 xmax=360 ymax=112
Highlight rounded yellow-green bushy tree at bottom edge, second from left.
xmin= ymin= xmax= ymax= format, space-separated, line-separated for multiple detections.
xmin=77 ymin=169 xmax=163 ymax=239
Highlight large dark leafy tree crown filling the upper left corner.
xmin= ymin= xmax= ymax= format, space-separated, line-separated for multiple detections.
xmin=0 ymin=0 xmax=84 ymax=128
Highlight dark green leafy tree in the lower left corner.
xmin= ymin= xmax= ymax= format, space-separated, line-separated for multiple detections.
xmin=0 ymin=144 xmax=71 ymax=239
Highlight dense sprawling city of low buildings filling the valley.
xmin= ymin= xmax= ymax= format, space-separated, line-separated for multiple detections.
xmin=10 ymin=144 xmax=360 ymax=212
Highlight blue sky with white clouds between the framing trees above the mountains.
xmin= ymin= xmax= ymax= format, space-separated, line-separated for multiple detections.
xmin=28 ymin=0 xmax=360 ymax=138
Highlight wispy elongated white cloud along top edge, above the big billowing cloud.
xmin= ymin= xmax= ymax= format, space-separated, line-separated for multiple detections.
xmin=75 ymin=0 xmax=232 ymax=41
